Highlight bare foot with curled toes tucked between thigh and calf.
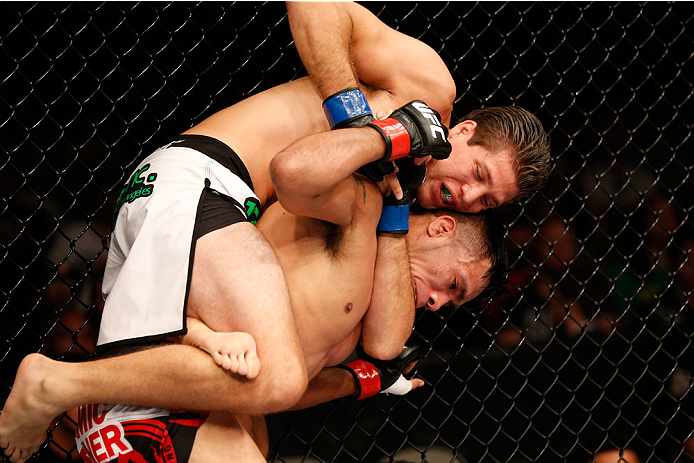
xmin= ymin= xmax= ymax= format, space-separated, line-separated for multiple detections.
xmin=203 ymin=332 xmax=260 ymax=379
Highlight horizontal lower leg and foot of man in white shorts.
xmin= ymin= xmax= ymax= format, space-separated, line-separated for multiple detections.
xmin=0 ymin=344 xmax=242 ymax=462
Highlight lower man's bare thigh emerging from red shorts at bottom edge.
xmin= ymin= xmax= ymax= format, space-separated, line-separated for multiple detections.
xmin=189 ymin=412 xmax=266 ymax=463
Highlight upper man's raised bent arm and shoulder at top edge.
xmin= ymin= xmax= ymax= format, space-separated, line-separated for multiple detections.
xmin=287 ymin=2 xmax=456 ymax=125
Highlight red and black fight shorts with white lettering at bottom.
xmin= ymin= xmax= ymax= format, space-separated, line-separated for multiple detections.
xmin=75 ymin=404 xmax=208 ymax=463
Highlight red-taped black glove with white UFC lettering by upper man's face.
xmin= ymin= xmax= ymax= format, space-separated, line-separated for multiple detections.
xmin=367 ymin=100 xmax=451 ymax=162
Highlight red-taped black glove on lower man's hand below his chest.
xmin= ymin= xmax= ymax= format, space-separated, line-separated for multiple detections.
xmin=337 ymin=341 xmax=426 ymax=399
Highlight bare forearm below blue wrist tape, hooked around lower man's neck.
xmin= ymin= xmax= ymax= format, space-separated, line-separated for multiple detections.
xmin=362 ymin=233 xmax=415 ymax=360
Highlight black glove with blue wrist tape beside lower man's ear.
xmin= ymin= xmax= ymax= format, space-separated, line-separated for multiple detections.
xmin=376 ymin=158 xmax=427 ymax=234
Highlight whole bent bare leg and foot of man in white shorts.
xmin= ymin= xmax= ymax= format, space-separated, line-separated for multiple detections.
xmin=0 ymin=223 xmax=307 ymax=461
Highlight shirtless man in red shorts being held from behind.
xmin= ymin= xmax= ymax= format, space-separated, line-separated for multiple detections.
xmin=78 ymin=102 xmax=506 ymax=462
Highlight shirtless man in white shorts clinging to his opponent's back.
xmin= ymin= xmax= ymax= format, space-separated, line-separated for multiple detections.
xmin=0 ymin=2 xmax=547 ymax=461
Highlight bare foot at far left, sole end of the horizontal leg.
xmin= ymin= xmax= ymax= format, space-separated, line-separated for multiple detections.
xmin=0 ymin=354 xmax=64 ymax=463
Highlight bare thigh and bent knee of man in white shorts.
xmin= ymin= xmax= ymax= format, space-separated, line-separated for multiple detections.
xmin=188 ymin=222 xmax=308 ymax=413
